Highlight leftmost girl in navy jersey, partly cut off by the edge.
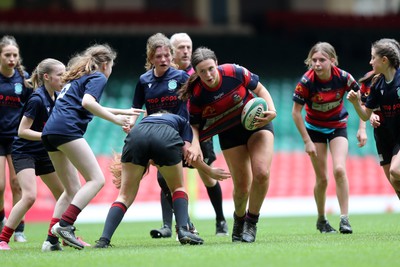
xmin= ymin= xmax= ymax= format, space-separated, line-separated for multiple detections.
xmin=0 ymin=35 xmax=32 ymax=242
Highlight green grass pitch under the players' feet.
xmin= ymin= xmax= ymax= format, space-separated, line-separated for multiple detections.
xmin=0 ymin=213 xmax=400 ymax=267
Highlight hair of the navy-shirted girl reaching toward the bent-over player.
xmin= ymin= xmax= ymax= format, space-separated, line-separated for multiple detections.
xmin=62 ymin=44 xmax=117 ymax=83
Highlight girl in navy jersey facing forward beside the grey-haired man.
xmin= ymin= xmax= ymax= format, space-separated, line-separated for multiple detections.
xmin=132 ymin=33 xmax=195 ymax=238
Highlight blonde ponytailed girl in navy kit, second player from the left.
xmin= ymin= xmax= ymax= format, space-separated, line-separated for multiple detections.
xmin=0 ymin=58 xmax=65 ymax=251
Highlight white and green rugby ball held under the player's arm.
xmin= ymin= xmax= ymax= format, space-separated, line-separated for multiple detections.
xmin=241 ymin=97 xmax=268 ymax=131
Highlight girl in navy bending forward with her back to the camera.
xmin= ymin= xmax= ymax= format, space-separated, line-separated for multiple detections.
xmin=95 ymin=113 xmax=230 ymax=248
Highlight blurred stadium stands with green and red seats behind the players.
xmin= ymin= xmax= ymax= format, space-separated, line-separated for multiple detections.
xmin=0 ymin=0 xmax=400 ymax=221
